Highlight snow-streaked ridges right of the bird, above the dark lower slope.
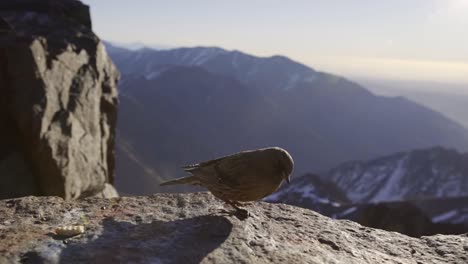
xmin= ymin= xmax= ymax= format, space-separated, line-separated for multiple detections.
xmin=268 ymin=147 xmax=468 ymax=205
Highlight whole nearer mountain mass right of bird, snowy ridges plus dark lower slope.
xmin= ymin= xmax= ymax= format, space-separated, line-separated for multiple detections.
xmin=265 ymin=147 xmax=468 ymax=236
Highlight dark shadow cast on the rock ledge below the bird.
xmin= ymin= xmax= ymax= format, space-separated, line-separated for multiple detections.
xmin=60 ymin=215 xmax=232 ymax=263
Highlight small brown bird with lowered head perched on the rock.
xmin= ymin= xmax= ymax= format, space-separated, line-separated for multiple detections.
xmin=160 ymin=147 xmax=294 ymax=217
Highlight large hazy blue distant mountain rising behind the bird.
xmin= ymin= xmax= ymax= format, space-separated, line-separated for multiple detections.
xmin=107 ymin=43 xmax=468 ymax=194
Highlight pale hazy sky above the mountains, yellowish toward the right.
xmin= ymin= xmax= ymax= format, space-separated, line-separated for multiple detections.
xmin=83 ymin=0 xmax=468 ymax=84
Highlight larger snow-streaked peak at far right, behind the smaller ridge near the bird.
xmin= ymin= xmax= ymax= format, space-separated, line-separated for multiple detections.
xmin=323 ymin=147 xmax=468 ymax=203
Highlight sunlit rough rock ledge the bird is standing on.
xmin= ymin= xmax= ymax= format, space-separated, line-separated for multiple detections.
xmin=0 ymin=193 xmax=468 ymax=263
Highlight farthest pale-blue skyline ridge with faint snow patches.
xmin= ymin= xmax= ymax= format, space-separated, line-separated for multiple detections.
xmin=107 ymin=43 xmax=362 ymax=96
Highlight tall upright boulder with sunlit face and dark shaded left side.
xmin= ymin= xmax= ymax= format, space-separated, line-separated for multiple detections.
xmin=0 ymin=0 xmax=119 ymax=199
